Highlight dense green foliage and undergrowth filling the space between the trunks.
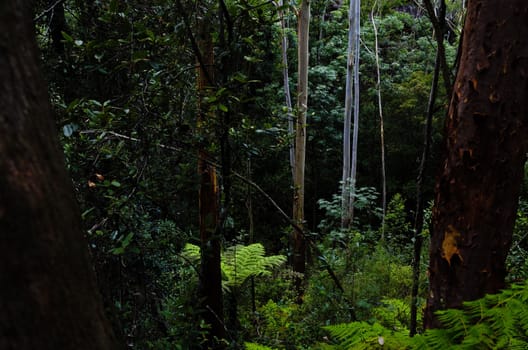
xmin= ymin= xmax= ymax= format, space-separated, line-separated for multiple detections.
xmin=32 ymin=0 xmax=528 ymax=350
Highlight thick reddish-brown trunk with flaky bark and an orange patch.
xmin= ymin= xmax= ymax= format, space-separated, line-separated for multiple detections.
xmin=425 ymin=0 xmax=528 ymax=328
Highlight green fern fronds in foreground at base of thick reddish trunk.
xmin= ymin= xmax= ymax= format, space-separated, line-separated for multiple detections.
xmin=325 ymin=282 xmax=528 ymax=350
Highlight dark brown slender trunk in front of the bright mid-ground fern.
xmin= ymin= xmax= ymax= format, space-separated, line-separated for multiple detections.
xmin=197 ymin=20 xmax=226 ymax=349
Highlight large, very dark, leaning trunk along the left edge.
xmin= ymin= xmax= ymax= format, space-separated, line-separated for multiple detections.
xmin=0 ymin=0 xmax=116 ymax=350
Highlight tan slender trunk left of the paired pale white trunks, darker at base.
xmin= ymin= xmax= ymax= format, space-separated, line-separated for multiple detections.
xmin=293 ymin=0 xmax=310 ymax=301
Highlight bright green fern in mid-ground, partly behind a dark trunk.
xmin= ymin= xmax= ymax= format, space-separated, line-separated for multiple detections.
xmin=181 ymin=243 xmax=286 ymax=291
